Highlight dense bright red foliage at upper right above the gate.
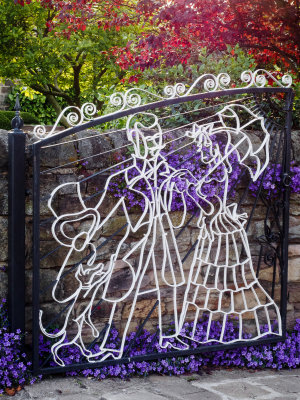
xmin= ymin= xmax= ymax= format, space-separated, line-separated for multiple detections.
xmin=113 ymin=0 xmax=300 ymax=71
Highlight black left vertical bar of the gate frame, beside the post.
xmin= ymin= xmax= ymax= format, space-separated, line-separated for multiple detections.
xmin=32 ymin=145 xmax=40 ymax=375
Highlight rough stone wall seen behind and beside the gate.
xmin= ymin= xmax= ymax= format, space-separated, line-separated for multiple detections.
xmin=0 ymin=126 xmax=300 ymax=336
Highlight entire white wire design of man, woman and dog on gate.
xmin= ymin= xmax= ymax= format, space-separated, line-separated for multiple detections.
xmin=40 ymin=104 xmax=281 ymax=365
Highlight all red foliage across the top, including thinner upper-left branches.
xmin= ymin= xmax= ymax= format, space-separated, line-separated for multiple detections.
xmin=16 ymin=0 xmax=300 ymax=71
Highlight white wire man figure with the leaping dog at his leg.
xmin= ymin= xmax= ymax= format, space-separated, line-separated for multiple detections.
xmin=40 ymin=113 xmax=203 ymax=365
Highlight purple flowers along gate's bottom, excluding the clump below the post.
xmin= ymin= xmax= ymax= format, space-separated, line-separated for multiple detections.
xmin=40 ymin=319 xmax=300 ymax=379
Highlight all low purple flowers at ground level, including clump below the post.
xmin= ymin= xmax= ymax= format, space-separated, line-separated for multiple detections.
xmin=0 ymin=299 xmax=300 ymax=388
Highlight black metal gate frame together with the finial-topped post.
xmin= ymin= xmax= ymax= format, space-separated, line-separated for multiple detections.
xmin=9 ymin=87 xmax=294 ymax=375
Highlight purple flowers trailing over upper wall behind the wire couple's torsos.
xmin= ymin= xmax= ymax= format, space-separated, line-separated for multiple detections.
xmin=108 ymin=138 xmax=300 ymax=211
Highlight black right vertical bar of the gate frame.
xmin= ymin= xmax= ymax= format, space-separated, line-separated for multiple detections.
xmin=280 ymin=89 xmax=294 ymax=337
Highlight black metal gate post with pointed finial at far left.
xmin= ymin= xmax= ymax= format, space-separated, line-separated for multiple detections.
xmin=8 ymin=95 xmax=25 ymax=333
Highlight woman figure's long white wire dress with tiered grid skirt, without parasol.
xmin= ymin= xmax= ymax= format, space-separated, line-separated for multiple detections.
xmin=180 ymin=133 xmax=281 ymax=343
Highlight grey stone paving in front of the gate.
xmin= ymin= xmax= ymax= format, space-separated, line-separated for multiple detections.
xmin=0 ymin=369 xmax=300 ymax=400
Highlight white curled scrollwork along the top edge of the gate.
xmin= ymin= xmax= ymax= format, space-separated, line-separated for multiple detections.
xmin=33 ymin=69 xmax=292 ymax=139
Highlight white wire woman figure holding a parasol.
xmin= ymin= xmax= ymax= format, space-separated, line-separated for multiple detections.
xmin=180 ymin=105 xmax=281 ymax=343
